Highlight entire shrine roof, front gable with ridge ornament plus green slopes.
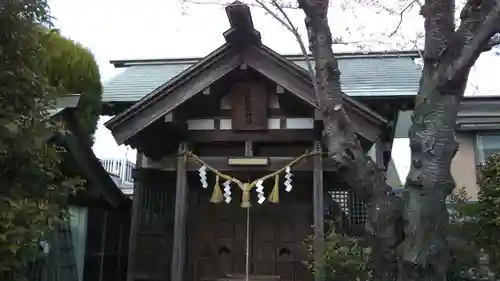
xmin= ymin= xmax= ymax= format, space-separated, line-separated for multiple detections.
xmin=104 ymin=2 xmax=430 ymax=147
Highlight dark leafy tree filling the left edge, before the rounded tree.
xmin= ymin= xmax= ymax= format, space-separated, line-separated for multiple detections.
xmin=0 ymin=0 xmax=79 ymax=281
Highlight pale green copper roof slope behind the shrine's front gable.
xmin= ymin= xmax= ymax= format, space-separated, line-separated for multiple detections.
xmin=103 ymin=54 xmax=421 ymax=102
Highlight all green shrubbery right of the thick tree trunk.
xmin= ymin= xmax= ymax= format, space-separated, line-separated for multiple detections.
xmin=447 ymin=154 xmax=500 ymax=280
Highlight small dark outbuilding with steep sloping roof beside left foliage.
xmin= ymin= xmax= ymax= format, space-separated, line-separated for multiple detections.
xmin=24 ymin=97 xmax=132 ymax=281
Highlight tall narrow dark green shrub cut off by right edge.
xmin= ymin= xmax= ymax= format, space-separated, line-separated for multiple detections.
xmin=476 ymin=154 xmax=500 ymax=272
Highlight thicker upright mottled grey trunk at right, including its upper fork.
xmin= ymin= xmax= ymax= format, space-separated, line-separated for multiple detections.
xmin=399 ymin=0 xmax=500 ymax=281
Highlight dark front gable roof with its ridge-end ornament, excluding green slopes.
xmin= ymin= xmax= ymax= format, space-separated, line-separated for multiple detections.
xmin=105 ymin=2 xmax=402 ymax=144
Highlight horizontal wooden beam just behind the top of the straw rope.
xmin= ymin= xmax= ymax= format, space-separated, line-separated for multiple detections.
xmin=143 ymin=156 xmax=336 ymax=172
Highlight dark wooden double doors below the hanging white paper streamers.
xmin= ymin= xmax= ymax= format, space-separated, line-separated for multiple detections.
xmin=188 ymin=189 xmax=312 ymax=281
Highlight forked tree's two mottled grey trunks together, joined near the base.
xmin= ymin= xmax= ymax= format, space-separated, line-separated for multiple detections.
xmin=298 ymin=0 xmax=500 ymax=281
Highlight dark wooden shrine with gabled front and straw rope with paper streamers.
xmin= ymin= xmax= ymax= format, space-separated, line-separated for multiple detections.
xmin=106 ymin=2 xmax=416 ymax=281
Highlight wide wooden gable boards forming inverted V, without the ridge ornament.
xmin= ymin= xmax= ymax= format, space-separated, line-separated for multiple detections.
xmin=105 ymin=45 xmax=385 ymax=144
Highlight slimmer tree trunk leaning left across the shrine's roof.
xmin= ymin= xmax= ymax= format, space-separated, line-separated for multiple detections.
xmin=299 ymin=0 xmax=403 ymax=281
